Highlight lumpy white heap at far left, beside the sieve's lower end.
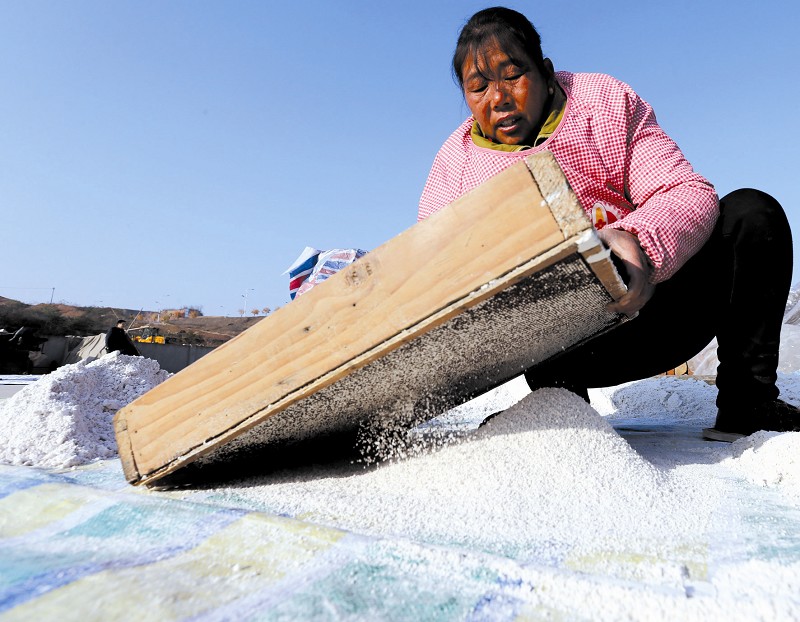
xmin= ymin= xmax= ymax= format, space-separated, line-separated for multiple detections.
xmin=0 ymin=352 xmax=171 ymax=468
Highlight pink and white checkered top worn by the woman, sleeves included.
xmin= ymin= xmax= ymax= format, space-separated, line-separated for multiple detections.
xmin=419 ymin=72 xmax=719 ymax=283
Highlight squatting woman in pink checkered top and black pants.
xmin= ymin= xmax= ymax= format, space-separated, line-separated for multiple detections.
xmin=419 ymin=7 xmax=800 ymax=441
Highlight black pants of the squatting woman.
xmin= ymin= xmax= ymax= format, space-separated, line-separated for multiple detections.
xmin=525 ymin=189 xmax=792 ymax=409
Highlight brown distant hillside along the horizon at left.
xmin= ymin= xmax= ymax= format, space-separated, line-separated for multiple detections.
xmin=0 ymin=296 xmax=263 ymax=346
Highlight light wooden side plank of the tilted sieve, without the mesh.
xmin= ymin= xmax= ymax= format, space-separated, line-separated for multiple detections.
xmin=114 ymin=153 xmax=614 ymax=483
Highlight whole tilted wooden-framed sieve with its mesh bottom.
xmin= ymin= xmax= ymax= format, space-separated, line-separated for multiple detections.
xmin=114 ymin=153 xmax=624 ymax=484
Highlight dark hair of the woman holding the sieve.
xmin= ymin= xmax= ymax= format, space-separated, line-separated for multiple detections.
xmin=453 ymin=6 xmax=549 ymax=90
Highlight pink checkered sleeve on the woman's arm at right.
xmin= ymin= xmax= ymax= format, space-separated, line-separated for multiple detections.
xmin=609 ymin=85 xmax=719 ymax=283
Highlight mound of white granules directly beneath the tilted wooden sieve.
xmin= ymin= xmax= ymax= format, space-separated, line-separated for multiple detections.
xmin=209 ymin=389 xmax=714 ymax=563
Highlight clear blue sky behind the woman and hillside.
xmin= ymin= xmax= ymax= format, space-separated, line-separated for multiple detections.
xmin=0 ymin=0 xmax=800 ymax=315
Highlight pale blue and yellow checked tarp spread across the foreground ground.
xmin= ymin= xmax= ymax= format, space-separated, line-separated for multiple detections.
xmin=0 ymin=408 xmax=800 ymax=622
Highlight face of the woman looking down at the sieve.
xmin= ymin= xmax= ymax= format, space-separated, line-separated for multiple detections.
xmin=461 ymin=44 xmax=552 ymax=145
